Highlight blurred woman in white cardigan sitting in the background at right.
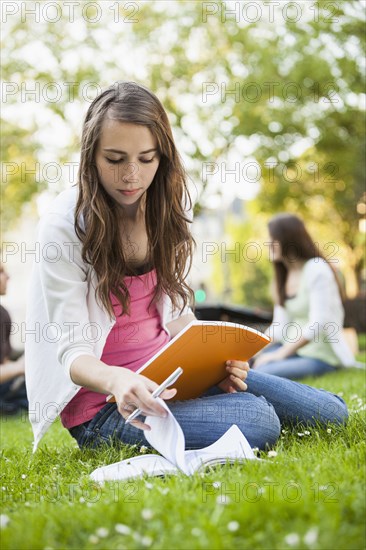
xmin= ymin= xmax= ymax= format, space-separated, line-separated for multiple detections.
xmin=252 ymin=214 xmax=355 ymax=379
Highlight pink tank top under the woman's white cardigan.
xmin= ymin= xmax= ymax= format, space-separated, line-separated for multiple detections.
xmin=60 ymin=270 xmax=170 ymax=428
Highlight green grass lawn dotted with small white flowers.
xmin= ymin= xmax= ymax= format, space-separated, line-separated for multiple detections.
xmin=0 ymin=357 xmax=366 ymax=550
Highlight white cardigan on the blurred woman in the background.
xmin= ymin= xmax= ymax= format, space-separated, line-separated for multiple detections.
xmin=266 ymin=258 xmax=355 ymax=367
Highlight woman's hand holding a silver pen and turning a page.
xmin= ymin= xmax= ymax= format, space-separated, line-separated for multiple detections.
xmin=112 ymin=367 xmax=177 ymax=430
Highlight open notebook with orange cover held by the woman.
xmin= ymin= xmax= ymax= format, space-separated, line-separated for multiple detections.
xmin=108 ymin=321 xmax=271 ymax=401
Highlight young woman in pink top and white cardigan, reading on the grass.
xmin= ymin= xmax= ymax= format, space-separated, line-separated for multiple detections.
xmin=26 ymin=82 xmax=347 ymax=449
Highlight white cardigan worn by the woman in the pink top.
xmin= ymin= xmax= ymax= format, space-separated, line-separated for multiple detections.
xmin=25 ymin=187 xmax=191 ymax=451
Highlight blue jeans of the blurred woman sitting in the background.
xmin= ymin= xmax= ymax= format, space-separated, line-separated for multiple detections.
xmin=255 ymin=344 xmax=337 ymax=380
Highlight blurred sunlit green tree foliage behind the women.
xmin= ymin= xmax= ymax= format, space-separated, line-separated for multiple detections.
xmin=3 ymin=0 xmax=365 ymax=293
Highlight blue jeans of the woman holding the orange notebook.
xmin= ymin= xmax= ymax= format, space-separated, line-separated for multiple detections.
xmin=70 ymin=370 xmax=348 ymax=449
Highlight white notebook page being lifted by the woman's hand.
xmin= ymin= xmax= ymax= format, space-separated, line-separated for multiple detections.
xmin=145 ymin=397 xmax=188 ymax=474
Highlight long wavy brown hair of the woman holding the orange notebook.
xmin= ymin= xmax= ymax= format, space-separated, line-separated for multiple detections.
xmin=75 ymin=82 xmax=194 ymax=317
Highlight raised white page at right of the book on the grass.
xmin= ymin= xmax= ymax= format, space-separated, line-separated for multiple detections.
xmin=184 ymin=424 xmax=257 ymax=473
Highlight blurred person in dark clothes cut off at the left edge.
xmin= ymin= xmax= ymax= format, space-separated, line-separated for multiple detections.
xmin=0 ymin=264 xmax=28 ymax=414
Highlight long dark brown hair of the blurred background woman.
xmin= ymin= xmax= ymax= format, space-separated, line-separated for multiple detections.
xmin=268 ymin=213 xmax=345 ymax=306
